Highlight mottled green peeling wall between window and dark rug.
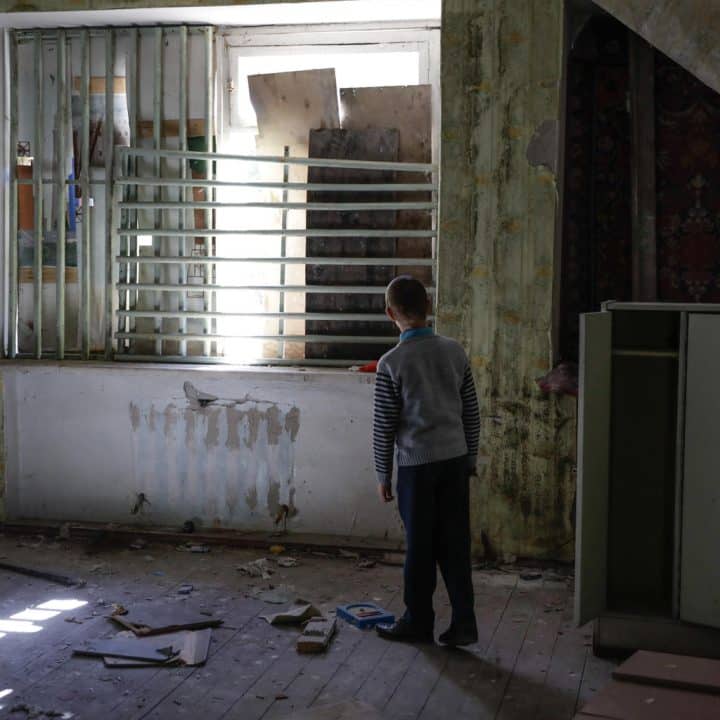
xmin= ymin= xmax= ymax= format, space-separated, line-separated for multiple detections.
xmin=0 ymin=0 xmax=575 ymax=558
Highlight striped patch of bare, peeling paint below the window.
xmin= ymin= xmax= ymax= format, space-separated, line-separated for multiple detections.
xmin=129 ymin=398 xmax=300 ymax=527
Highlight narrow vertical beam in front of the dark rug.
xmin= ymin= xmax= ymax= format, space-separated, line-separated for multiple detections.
xmin=628 ymin=31 xmax=657 ymax=301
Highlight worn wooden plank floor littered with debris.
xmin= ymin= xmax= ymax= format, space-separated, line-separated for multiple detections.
xmin=0 ymin=537 xmax=612 ymax=720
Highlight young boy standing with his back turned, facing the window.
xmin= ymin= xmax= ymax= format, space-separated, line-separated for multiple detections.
xmin=373 ymin=275 xmax=480 ymax=646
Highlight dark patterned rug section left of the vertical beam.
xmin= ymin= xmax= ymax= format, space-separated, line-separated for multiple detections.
xmin=560 ymin=18 xmax=632 ymax=360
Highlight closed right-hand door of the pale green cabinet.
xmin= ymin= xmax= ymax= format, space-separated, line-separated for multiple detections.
xmin=680 ymin=313 xmax=720 ymax=627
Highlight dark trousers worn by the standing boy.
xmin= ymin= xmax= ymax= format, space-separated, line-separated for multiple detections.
xmin=397 ymin=456 xmax=475 ymax=631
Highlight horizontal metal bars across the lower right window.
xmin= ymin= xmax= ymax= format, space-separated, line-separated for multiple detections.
xmin=109 ymin=147 xmax=437 ymax=366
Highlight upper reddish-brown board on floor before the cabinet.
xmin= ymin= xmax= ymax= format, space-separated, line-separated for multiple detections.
xmin=613 ymin=650 xmax=720 ymax=695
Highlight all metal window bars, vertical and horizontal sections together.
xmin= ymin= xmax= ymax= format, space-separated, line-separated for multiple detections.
xmin=5 ymin=26 xmax=437 ymax=365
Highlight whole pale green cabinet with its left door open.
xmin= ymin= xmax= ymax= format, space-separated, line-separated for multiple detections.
xmin=575 ymin=302 xmax=720 ymax=657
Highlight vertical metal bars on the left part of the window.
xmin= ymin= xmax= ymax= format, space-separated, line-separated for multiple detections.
xmin=4 ymin=26 xmax=215 ymax=360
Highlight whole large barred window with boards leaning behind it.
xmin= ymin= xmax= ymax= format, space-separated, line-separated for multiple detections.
xmin=9 ymin=14 xmax=439 ymax=366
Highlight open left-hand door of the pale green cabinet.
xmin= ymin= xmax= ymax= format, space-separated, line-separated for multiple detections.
xmin=575 ymin=312 xmax=612 ymax=625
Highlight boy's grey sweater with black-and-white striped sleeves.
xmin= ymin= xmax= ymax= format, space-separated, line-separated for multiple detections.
xmin=373 ymin=328 xmax=480 ymax=484
